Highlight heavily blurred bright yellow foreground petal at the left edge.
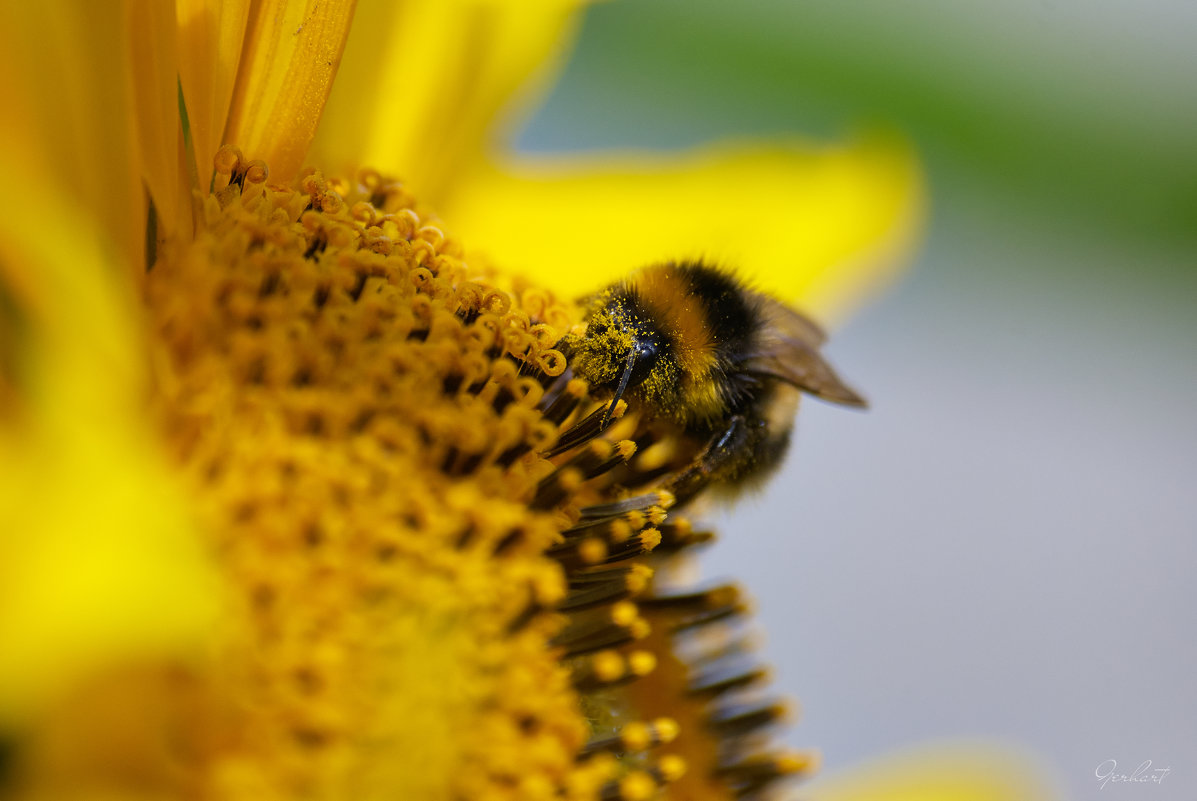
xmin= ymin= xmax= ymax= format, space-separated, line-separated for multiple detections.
xmin=0 ymin=153 xmax=217 ymax=717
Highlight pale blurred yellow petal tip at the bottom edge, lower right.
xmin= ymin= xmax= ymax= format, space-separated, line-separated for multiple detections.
xmin=802 ymin=744 xmax=1063 ymax=801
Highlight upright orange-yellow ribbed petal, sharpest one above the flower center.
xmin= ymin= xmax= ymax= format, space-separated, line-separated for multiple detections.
xmin=225 ymin=0 xmax=354 ymax=182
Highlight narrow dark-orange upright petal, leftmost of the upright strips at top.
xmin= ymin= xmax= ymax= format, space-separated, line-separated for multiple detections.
xmin=123 ymin=0 xmax=190 ymax=237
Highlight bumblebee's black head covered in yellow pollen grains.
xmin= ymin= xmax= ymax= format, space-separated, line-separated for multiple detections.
xmin=570 ymin=290 xmax=678 ymax=424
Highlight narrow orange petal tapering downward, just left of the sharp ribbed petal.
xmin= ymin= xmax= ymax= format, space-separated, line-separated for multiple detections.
xmin=175 ymin=0 xmax=249 ymax=190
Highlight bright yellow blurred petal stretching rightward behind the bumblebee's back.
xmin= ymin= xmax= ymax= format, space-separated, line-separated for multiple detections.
xmin=440 ymin=141 xmax=923 ymax=320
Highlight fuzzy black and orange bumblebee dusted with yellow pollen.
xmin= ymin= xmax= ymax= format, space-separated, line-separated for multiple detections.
xmin=565 ymin=261 xmax=865 ymax=503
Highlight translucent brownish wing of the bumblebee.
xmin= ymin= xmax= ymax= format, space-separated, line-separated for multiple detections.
xmin=745 ymin=296 xmax=868 ymax=407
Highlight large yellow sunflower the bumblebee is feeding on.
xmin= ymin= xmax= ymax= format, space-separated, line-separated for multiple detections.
xmin=0 ymin=0 xmax=1038 ymax=799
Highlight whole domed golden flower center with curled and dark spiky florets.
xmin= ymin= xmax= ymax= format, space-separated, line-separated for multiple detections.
xmin=126 ymin=147 xmax=818 ymax=799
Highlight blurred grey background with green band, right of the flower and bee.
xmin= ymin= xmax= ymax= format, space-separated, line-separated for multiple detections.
xmin=518 ymin=0 xmax=1197 ymax=801
